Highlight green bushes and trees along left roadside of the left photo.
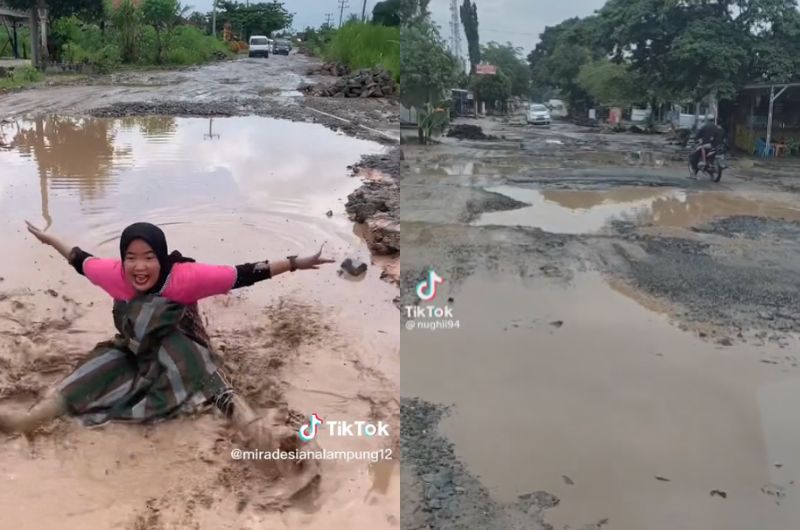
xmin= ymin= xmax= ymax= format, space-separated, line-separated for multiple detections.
xmin=0 ymin=0 xmax=292 ymax=85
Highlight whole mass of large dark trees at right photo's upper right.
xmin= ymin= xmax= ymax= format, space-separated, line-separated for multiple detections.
xmin=528 ymin=0 xmax=800 ymax=122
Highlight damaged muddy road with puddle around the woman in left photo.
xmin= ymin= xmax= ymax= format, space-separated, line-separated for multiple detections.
xmin=0 ymin=55 xmax=400 ymax=530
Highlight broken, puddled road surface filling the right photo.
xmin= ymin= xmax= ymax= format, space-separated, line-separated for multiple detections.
xmin=401 ymin=115 xmax=800 ymax=530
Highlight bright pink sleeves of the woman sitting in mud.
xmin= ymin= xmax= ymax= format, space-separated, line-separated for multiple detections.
xmin=83 ymin=256 xmax=237 ymax=304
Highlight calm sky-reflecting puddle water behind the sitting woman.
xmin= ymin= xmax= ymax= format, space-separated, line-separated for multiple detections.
xmin=0 ymin=117 xmax=382 ymax=250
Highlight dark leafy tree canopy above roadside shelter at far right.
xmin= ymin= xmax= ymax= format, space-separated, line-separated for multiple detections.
xmin=599 ymin=0 xmax=800 ymax=104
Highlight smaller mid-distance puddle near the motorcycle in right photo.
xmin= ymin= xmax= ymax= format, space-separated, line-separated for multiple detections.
xmin=473 ymin=186 xmax=800 ymax=234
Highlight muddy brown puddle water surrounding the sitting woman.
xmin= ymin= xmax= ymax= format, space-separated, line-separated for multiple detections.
xmin=0 ymin=117 xmax=400 ymax=529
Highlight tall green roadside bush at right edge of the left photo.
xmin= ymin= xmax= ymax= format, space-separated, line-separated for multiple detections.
xmin=322 ymin=22 xmax=400 ymax=81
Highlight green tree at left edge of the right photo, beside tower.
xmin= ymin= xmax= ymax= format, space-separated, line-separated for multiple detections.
xmin=400 ymin=20 xmax=458 ymax=144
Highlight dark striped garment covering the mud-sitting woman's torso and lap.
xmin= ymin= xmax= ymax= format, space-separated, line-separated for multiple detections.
xmin=58 ymin=295 xmax=233 ymax=425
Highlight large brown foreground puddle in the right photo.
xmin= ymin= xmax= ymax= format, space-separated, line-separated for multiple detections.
xmin=402 ymin=273 xmax=800 ymax=530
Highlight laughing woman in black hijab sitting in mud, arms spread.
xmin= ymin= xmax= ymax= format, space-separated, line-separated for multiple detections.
xmin=0 ymin=219 xmax=333 ymax=493
